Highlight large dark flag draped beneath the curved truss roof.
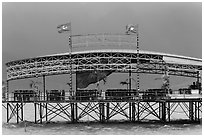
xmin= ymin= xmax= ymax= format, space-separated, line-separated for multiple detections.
xmin=77 ymin=71 xmax=112 ymax=88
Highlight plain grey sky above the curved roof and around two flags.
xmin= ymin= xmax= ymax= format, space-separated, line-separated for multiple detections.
xmin=2 ymin=2 xmax=202 ymax=91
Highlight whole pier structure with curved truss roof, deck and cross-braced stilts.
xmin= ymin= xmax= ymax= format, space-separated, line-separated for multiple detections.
xmin=2 ymin=34 xmax=202 ymax=123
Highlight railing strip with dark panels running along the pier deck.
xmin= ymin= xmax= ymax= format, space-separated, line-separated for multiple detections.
xmin=2 ymin=89 xmax=202 ymax=102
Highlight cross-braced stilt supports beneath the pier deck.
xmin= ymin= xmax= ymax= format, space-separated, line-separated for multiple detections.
xmin=3 ymin=95 xmax=202 ymax=123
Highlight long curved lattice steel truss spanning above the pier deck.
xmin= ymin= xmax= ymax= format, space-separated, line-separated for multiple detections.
xmin=6 ymin=51 xmax=202 ymax=80
